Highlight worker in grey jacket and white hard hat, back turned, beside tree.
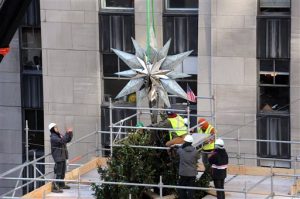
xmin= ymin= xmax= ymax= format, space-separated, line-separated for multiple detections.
xmin=177 ymin=135 xmax=200 ymax=199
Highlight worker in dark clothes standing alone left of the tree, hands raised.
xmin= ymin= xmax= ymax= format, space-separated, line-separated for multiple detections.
xmin=48 ymin=123 xmax=73 ymax=193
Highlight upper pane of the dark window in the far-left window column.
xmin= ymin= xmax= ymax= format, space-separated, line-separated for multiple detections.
xmin=21 ymin=27 xmax=41 ymax=48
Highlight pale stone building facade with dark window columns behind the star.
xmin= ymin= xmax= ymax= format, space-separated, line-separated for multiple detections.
xmin=0 ymin=0 xmax=300 ymax=193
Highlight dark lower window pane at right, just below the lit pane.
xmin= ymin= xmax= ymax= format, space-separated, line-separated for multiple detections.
xmin=260 ymin=86 xmax=290 ymax=112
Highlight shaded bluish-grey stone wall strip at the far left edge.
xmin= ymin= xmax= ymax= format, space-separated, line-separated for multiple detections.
xmin=0 ymin=32 xmax=22 ymax=195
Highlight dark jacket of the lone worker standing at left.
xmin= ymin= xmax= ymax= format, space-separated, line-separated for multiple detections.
xmin=50 ymin=132 xmax=73 ymax=162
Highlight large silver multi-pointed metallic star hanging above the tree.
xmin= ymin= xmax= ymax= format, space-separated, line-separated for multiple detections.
xmin=112 ymin=39 xmax=192 ymax=107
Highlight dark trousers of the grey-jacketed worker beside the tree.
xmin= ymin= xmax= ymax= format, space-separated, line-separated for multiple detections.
xmin=179 ymin=176 xmax=196 ymax=199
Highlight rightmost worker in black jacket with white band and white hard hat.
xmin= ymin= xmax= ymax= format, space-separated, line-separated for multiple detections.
xmin=208 ymin=138 xmax=228 ymax=199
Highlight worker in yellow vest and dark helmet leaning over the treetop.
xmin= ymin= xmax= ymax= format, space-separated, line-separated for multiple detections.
xmin=153 ymin=111 xmax=187 ymax=147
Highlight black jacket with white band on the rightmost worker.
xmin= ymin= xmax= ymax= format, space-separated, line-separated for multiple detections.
xmin=208 ymin=148 xmax=228 ymax=180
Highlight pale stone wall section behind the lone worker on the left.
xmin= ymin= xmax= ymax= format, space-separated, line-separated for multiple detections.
xmin=41 ymin=0 xmax=101 ymax=169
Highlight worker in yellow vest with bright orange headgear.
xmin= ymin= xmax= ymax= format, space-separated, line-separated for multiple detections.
xmin=198 ymin=118 xmax=216 ymax=173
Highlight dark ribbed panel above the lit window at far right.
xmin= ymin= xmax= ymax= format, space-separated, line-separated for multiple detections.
xmin=257 ymin=18 xmax=291 ymax=59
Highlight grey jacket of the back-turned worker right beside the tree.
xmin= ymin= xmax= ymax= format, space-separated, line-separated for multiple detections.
xmin=177 ymin=145 xmax=200 ymax=177
